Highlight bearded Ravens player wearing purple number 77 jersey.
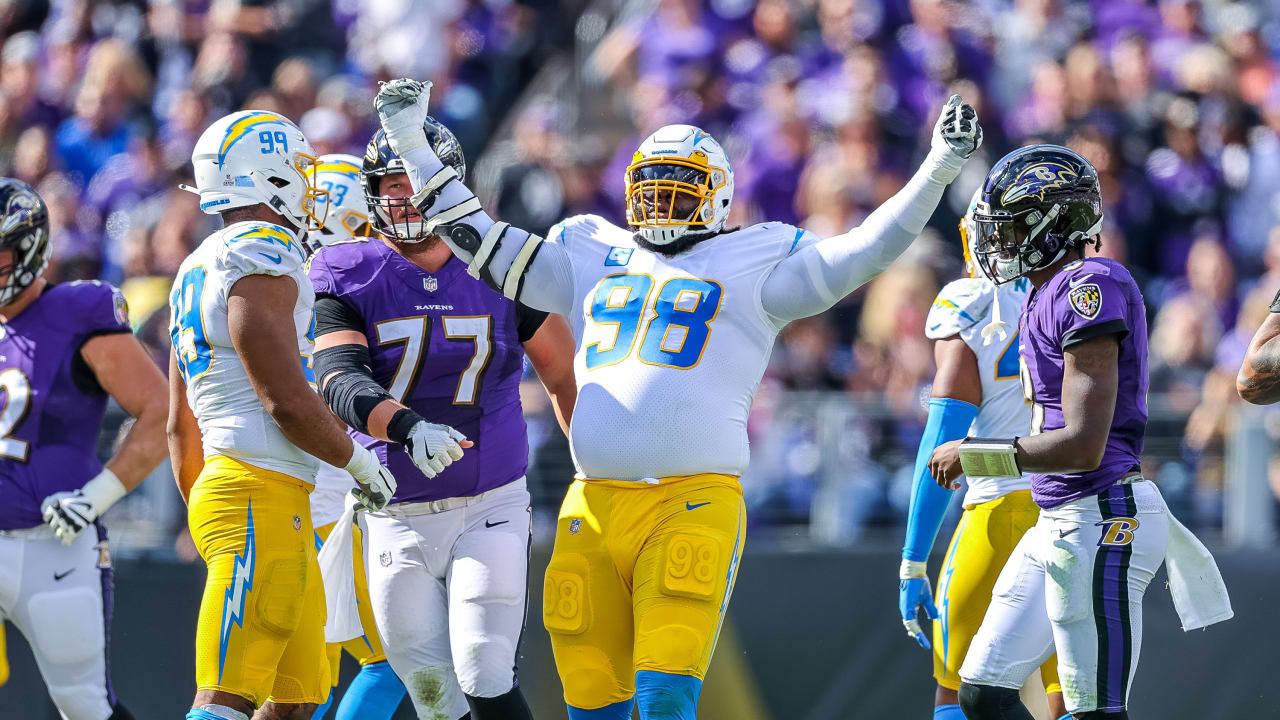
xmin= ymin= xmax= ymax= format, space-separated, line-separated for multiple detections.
xmin=310 ymin=118 xmax=576 ymax=720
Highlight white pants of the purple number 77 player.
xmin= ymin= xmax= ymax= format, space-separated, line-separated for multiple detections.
xmin=358 ymin=478 xmax=530 ymax=719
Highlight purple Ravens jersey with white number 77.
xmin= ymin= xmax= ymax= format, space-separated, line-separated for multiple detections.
xmin=310 ymin=240 xmax=529 ymax=502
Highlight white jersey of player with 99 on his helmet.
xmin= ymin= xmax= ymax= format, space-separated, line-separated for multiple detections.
xmin=169 ymin=215 xmax=319 ymax=483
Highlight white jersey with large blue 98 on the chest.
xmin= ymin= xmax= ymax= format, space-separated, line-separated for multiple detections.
xmin=548 ymin=215 xmax=813 ymax=480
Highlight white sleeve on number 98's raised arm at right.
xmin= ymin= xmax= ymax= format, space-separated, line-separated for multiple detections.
xmin=760 ymin=150 xmax=964 ymax=324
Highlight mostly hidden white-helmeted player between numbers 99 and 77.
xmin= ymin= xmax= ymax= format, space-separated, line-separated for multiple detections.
xmin=305 ymin=152 xmax=404 ymax=720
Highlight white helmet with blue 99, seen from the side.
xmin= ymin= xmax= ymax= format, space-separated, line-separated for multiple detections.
xmin=192 ymin=110 xmax=328 ymax=231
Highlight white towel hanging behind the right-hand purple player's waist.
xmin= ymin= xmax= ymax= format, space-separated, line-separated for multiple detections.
xmin=1165 ymin=506 xmax=1235 ymax=630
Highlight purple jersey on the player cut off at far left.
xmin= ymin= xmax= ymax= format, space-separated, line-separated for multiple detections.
xmin=0 ymin=282 xmax=129 ymax=530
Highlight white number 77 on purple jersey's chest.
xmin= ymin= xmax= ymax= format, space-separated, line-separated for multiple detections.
xmin=374 ymin=315 xmax=494 ymax=405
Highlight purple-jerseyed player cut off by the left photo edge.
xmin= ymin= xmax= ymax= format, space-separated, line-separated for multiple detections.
xmin=0 ymin=178 xmax=168 ymax=720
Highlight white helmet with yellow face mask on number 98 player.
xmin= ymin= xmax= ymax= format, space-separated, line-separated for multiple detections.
xmin=626 ymin=126 xmax=733 ymax=245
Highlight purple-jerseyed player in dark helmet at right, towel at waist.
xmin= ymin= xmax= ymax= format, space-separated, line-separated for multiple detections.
xmin=929 ymin=145 xmax=1231 ymax=720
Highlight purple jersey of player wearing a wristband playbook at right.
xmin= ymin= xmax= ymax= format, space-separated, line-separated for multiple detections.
xmin=1020 ymin=258 xmax=1147 ymax=507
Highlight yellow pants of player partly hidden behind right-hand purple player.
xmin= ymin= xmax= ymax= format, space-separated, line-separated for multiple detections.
xmin=933 ymin=489 xmax=1062 ymax=693
